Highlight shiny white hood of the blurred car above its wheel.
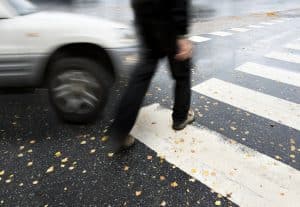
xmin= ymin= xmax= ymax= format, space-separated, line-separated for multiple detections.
xmin=23 ymin=12 xmax=136 ymax=47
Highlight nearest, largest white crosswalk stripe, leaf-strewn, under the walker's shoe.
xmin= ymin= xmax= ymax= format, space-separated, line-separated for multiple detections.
xmin=131 ymin=103 xmax=300 ymax=207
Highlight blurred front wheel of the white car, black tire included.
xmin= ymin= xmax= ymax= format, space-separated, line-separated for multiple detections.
xmin=48 ymin=57 xmax=111 ymax=124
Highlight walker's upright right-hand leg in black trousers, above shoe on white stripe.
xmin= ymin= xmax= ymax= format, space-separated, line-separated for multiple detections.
xmin=168 ymin=55 xmax=191 ymax=123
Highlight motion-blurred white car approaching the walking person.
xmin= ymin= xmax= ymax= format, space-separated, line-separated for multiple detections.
xmin=0 ymin=0 xmax=137 ymax=122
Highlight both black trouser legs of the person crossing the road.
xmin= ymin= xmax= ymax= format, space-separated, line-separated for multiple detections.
xmin=111 ymin=50 xmax=191 ymax=141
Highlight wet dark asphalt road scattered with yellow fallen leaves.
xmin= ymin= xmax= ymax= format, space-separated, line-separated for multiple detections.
xmin=0 ymin=2 xmax=300 ymax=207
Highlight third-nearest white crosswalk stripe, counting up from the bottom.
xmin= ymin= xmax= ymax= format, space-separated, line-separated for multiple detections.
xmin=236 ymin=62 xmax=300 ymax=87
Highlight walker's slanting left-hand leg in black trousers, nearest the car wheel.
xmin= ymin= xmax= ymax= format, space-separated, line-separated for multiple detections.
xmin=110 ymin=53 xmax=158 ymax=143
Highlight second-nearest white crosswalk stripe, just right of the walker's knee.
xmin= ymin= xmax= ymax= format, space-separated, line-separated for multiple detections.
xmin=193 ymin=78 xmax=300 ymax=130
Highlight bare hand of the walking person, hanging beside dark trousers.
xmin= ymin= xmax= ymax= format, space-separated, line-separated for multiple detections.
xmin=175 ymin=38 xmax=193 ymax=61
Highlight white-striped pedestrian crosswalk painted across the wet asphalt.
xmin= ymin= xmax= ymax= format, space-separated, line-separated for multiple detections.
xmin=131 ymin=29 xmax=300 ymax=207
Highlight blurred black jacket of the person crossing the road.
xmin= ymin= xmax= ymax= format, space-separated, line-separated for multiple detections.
xmin=131 ymin=0 xmax=189 ymax=56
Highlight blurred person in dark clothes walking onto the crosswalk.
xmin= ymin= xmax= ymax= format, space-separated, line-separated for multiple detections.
xmin=110 ymin=0 xmax=194 ymax=150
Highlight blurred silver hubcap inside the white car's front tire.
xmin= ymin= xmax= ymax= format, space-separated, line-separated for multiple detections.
xmin=51 ymin=71 xmax=101 ymax=114
